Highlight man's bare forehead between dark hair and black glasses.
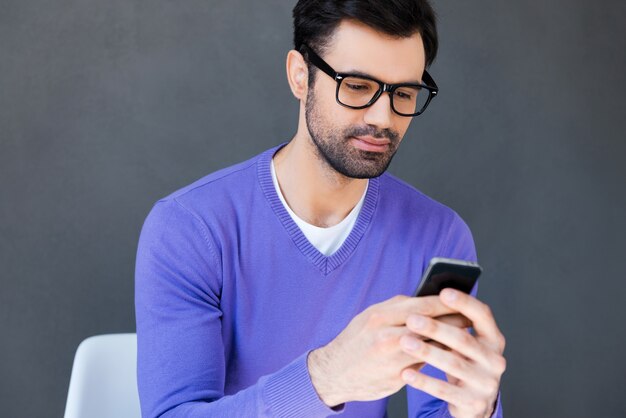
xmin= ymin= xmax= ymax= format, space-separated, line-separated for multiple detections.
xmin=325 ymin=20 xmax=426 ymax=83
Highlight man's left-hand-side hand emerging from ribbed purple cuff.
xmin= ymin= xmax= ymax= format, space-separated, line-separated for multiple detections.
xmin=307 ymin=295 xmax=460 ymax=407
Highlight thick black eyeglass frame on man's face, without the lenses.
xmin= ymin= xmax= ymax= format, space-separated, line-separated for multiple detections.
xmin=300 ymin=44 xmax=439 ymax=117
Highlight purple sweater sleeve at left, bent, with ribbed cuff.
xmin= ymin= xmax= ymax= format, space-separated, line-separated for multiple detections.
xmin=135 ymin=199 xmax=341 ymax=418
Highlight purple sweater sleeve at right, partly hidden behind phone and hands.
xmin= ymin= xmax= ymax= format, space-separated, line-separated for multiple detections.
xmin=407 ymin=213 xmax=503 ymax=418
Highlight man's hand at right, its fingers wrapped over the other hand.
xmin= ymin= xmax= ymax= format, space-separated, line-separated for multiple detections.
xmin=401 ymin=289 xmax=506 ymax=418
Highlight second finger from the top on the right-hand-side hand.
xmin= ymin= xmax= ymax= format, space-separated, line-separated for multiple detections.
xmin=406 ymin=315 xmax=489 ymax=366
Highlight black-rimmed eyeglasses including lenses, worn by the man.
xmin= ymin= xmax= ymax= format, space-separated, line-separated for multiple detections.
xmin=301 ymin=44 xmax=439 ymax=117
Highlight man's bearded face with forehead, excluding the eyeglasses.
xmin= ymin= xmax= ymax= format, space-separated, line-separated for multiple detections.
xmin=305 ymin=20 xmax=425 ymax=178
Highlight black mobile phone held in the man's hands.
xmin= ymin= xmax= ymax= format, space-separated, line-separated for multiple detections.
xmin=415 ymin=257 xmax=483 ymax=297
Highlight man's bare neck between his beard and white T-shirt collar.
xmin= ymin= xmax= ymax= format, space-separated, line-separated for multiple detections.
xmin=274 ymin=136 xmax=367 ymax=227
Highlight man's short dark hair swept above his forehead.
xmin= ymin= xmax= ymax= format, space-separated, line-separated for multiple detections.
xmin=293 ymin=0 xmax=439 ymax=67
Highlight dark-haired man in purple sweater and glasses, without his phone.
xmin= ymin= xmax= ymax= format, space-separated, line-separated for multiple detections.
xmin=136 ymin=0 xmax=505 ymax=417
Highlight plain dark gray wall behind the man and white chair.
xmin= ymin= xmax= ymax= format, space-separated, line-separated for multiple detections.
xmin=0 ymin=0 xmax=626 ymax=418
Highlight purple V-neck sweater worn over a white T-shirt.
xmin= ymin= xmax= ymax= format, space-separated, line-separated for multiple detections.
xmin=135 ymin=142 xmax=500 ymax=418
